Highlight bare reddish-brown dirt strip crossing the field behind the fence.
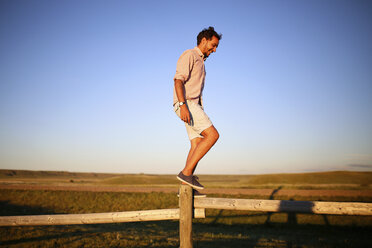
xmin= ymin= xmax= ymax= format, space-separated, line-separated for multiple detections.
xmin=0 ymin=184 xmax=372 ymax=197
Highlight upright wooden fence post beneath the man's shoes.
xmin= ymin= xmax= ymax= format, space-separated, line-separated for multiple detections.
xmin=179 ymin=184 xmax=193 ymax=248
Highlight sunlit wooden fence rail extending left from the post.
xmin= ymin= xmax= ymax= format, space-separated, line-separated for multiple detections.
xmin=0 ymin=208 xmax=205 ymax=226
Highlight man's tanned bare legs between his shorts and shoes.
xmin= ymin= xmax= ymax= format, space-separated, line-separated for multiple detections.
xmin=182 ymin=126 xmax=220 ymax=176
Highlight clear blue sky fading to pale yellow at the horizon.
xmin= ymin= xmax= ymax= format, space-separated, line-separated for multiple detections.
xmin=0 ymin=0 xmax=372 ymax=174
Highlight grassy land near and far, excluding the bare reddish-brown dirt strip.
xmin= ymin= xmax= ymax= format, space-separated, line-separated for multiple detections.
xmin=0 ymin=170 xmax=372 ymax=248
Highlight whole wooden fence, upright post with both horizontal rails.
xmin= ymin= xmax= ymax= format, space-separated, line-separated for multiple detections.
xmin=0 ymin=185 xmax=372 ymax=248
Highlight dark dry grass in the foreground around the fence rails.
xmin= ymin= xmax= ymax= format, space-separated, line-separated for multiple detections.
xmin=0 ymin=190 xmax=372 ymax=248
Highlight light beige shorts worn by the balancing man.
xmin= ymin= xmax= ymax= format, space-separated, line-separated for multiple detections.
xmin=174 ymin=100 xmax=213 ymax=140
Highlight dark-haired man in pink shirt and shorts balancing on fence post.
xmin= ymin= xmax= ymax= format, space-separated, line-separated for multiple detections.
xmin=173 ymin=27 xmax=222 ymax=196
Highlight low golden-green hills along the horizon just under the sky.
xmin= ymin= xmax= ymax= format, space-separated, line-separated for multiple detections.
xmin=0 ymin=170 xmax=372 ymax=187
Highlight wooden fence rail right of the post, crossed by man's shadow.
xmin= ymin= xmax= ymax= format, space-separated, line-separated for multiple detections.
xmin=194 ymin=197 xmax=372 ymax=215
